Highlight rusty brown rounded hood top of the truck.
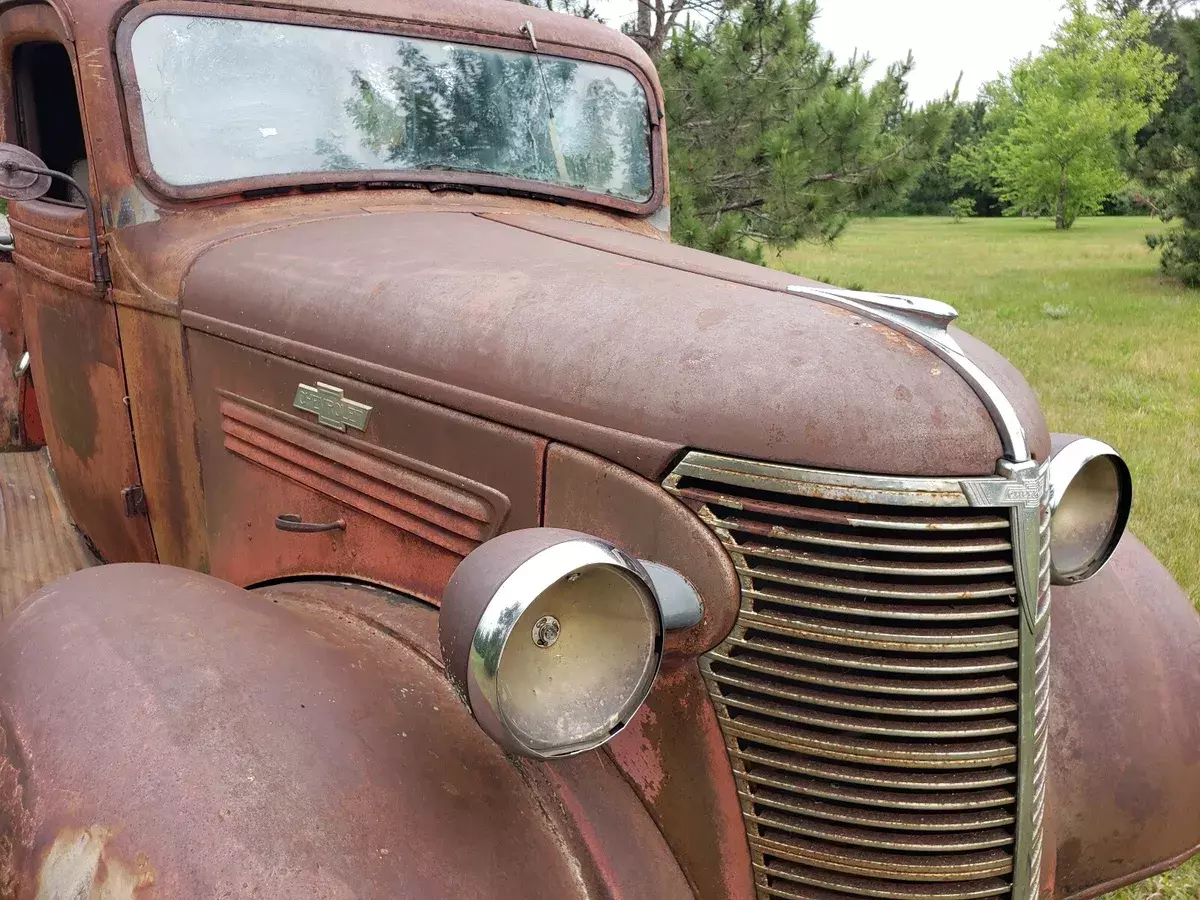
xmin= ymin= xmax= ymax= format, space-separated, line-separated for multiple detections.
xmin=181 ymin=211 xmax=1049 ymax=478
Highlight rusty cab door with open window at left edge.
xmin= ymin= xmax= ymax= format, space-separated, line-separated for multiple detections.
xmin=0 ymin=4 xmax=155 ymax=562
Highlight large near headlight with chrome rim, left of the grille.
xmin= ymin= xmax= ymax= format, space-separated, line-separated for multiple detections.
xmin=438 ymin=528 xmax=664 ymax=758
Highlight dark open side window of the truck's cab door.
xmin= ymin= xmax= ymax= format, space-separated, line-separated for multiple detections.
xmin=12 ymin=41 xmax=88 ymax=204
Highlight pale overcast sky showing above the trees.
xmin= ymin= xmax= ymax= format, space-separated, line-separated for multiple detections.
xmin=596 ymin=0 xmax=1062 ymax=103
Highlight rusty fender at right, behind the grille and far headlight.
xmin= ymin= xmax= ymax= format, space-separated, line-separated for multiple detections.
xmin=1048 ymin=534 xmax=1200 ymax=900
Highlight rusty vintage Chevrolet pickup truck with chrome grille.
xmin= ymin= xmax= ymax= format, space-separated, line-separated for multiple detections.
xmin=0 ymin=0 xmax=1200 ymax=900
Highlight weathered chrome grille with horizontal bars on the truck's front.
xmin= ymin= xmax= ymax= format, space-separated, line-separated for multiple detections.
xmin=664 ymin=452 xmax=1050 ymax=900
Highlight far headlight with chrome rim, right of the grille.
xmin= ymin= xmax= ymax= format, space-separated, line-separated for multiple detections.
xmin=1049 ymin=438 xmax=1133 ymax=584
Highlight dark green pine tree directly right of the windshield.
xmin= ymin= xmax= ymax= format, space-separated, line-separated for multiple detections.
xmin=659 ymin=0 xmax=953 ymax=260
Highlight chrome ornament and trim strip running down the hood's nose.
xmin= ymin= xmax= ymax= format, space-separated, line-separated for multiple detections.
xmin=787 ymin=284 xmax=1032 ymax=462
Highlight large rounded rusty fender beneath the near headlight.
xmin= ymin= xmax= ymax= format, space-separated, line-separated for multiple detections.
xmin=0 ymin=564 xmax=691 ymax=900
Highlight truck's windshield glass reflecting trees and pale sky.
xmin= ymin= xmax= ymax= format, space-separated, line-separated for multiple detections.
xmin=131 ymin=16 xmax=652 ymax=202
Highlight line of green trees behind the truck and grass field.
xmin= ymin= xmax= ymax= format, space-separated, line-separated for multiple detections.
xmin=520 ymin=0 xmax=1200 ymax=287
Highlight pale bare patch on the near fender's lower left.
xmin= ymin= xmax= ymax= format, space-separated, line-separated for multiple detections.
xmin=37 ymin=826 xmax=154 ymax=900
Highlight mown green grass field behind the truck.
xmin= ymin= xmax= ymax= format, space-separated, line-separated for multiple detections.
xmin=772 ymin=218 xmax=1200 ymax=900
